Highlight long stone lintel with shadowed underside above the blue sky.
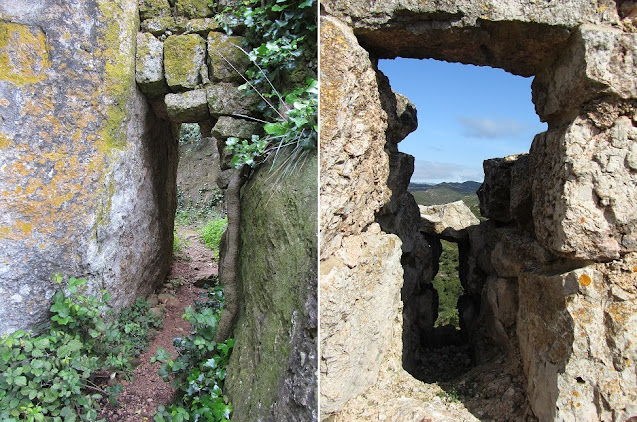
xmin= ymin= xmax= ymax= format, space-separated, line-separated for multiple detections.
xmin=321 ymin=0 xmax=619 ymax=76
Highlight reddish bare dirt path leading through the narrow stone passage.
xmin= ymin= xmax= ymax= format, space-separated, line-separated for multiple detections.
xmin=100 ymin=226 xmax=217 ymax=422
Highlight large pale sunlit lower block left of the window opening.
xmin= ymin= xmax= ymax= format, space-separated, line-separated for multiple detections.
xmin=319 ymin=223 xmax=403 ymax=418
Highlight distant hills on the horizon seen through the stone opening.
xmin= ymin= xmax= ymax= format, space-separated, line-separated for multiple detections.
xmin=407 ymin=181 xmax=481 ymax=217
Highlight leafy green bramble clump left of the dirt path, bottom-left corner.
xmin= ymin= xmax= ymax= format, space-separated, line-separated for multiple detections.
xmin=0 ymin=274 xmax=164 ymax=421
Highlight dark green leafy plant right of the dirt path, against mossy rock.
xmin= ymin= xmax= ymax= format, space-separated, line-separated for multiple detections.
xmin=151 ymin=286 xmax=234 ymax=422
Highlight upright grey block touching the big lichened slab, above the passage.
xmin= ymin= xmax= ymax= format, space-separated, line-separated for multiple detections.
xmin=135 ymin=32 xmax=168 ymax=97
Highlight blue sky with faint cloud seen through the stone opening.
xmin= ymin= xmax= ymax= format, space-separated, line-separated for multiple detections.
xmin=379 ymin=59 xmax=546 ymax=183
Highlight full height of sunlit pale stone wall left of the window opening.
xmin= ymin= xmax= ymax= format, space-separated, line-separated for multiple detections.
xmin=319 ymin=17 xmax=403 ymax=419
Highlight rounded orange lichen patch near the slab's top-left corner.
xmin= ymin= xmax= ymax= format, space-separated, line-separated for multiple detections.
xmin=0 ymin=21 xmax=51 ymax=86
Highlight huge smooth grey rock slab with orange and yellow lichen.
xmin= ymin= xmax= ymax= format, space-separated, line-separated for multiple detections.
xmin=0 ymin=0 xmax=176 ymax=332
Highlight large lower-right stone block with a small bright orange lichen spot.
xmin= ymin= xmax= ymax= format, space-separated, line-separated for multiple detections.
xmin=517 ymin=254 xmax=637 ymax=421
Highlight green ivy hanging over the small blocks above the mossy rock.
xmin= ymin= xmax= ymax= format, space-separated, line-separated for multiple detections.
xmin=220 ymin=0 xmax=318 ymax=168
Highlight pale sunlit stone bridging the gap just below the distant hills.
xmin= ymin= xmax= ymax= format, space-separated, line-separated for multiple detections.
xmin=418 ymin=201 xmax=480 ymax=242
